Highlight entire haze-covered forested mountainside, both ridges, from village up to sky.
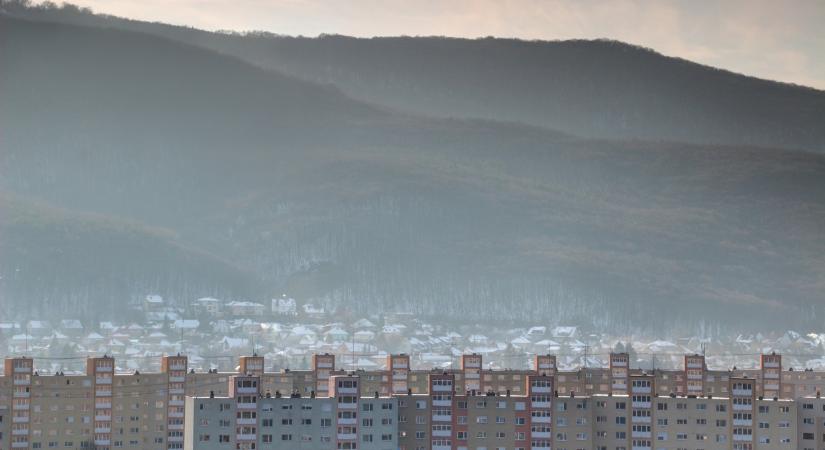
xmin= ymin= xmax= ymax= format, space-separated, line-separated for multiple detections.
xmin=0 ymin=3 xmax=825 ymax=330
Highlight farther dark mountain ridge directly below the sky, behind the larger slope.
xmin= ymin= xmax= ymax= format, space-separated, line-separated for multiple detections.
xmin=10 ymin=0 xmax=825 ymax=152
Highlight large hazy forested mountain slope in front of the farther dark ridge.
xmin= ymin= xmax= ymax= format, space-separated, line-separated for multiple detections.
xmin=0 ymin=15 xmax=825 ymax=330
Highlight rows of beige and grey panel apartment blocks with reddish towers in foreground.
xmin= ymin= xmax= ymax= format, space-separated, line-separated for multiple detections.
xmin=0 ymin=354 xmax=825 ymax=450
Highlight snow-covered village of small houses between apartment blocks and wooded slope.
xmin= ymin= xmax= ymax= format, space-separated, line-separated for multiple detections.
xmin=0 ymin=295 xmax=825 ymax=373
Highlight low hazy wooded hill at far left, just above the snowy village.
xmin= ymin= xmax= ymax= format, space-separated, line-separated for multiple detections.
xmin=0 ymin=195 xmax=260 ymax=321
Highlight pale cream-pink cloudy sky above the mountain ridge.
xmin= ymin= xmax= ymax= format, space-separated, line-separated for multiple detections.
xmin=68 ymin=0 xmax=825 ymax=89
